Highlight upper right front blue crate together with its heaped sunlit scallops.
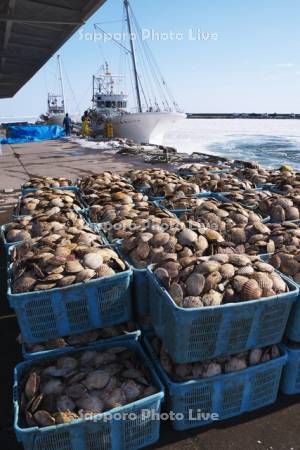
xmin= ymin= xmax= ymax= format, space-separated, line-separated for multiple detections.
xmin=149 ymin=254 xmax=299 ymax=363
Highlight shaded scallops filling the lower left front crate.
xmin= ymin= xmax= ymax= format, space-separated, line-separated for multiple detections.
xmin=19 ymin=345 xmax=158 ymax=428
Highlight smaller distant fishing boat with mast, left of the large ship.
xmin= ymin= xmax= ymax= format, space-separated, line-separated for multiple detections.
xmin=41 ymin=55 xmax=66 ymax=126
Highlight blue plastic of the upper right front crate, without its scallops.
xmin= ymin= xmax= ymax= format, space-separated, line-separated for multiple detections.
xmin=149 ymin=267 xmax=299 ymax=363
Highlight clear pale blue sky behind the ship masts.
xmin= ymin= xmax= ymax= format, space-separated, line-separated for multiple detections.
xmin=0 ymin=0 xmax=300 ymax=117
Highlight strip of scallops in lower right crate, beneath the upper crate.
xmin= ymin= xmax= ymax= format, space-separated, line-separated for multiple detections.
xmin=150 ymin=336 xmax=281 ymax=383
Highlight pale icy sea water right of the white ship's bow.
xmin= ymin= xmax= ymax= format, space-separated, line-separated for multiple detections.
xmin=163 ymin=119 xmax=300 ymax=169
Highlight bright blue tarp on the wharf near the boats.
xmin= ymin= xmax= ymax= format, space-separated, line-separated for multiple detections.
xmin=0 ymin=125 xmax=65 ymax=144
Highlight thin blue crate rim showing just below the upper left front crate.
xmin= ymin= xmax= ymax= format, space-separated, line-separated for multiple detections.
xmin=22 ymin=329 xmax=141 ymax=359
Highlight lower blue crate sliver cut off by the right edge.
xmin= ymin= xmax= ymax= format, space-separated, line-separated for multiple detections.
xmin=280 ymin=346 xmax=300 ymax=395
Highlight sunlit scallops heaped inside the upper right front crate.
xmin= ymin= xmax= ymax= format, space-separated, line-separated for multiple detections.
xmin=153 ymin=254 xmax=289 ymax=308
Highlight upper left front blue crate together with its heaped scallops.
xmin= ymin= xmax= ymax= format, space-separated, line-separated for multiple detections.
xmin=7 ymin=244 xmax=132 ymax=344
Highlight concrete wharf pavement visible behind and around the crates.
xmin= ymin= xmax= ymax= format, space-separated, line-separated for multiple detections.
xmin=0 ymin=141 xmax=300 ymax=450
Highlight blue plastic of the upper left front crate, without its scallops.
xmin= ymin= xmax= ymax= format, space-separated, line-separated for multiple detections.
xmin=7 ymin=253 xmax=133 ymax=344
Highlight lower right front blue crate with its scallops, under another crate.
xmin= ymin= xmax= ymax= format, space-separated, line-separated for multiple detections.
xmin=144 ymin=336 xmax=287 ymax=431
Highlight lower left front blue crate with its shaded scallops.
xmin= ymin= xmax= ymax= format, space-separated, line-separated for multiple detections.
xmin=14 ymin=339 xmax=164 ymax=450
